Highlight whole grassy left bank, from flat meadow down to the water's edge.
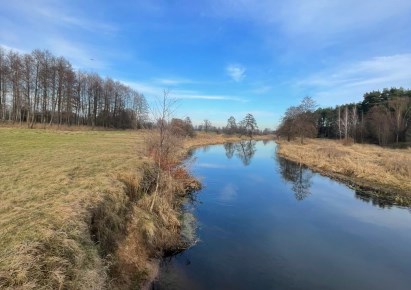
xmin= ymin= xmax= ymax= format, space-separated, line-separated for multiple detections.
xmin=0 ymin=127 xmax=268 ymax=289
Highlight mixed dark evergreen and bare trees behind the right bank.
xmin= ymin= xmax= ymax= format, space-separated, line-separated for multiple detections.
xmin=277 ymin=88 xmax=411 ymax=146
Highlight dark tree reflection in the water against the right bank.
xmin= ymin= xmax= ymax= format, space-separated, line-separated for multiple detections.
xmin=277 ymin=156 xmax=313 ymax=200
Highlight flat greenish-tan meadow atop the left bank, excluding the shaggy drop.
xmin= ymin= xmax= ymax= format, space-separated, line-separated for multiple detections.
xmin=0 ymin=128 xmax=150 ymax=289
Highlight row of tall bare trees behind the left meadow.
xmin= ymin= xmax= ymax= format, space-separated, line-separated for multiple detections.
xmin=0 ymin=47 xmax=148 ymax=128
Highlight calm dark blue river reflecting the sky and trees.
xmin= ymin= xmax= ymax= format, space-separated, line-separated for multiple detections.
xmin=153 ymin=142 xmax=411 ymax=289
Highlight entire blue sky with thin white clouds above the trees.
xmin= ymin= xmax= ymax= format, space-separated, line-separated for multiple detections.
xmin=0 ymin=0 xmax=411 ymax=129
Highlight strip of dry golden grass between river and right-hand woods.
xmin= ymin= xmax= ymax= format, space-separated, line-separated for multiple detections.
xmin=278 ymin=139 xmax=411 ymax=194
